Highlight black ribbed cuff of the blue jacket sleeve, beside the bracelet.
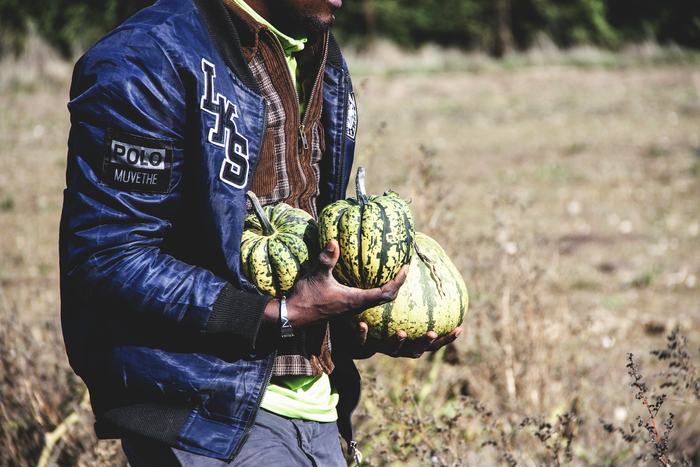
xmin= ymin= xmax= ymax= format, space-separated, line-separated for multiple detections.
xmin=206 ymin=284 xmax=272 ymax=348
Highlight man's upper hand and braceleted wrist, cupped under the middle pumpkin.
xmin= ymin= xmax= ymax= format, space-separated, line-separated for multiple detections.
xmin=265 ymin=240 xmax=408 ymax=329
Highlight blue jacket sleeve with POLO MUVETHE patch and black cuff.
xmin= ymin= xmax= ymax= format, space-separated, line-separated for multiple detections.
xmin=59 ymin=25 xmax=271 ymax=346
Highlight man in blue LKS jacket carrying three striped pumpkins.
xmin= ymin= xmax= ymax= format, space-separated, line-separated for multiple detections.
xmin=60 ymin=0 xmax=460 ymax=467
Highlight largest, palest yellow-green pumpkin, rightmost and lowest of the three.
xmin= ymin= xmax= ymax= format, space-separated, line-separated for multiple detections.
xmin=350 ymin=232 xmax=469 ymax=340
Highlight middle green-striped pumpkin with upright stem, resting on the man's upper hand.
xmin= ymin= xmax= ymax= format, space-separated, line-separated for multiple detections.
xmin=318 ymin=167 xmax=415 ymax=289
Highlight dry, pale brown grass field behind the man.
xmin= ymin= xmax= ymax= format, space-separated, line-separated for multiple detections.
xmin=0 ymin=42 xmax=700 ymax=467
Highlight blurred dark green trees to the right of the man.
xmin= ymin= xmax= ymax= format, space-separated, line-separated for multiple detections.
xmin=338 ymin=0 xmax=700 ymax=56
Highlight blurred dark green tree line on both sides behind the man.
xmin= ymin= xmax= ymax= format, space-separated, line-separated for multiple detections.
xmin=0 ymin=0 xmax=700 ymax=56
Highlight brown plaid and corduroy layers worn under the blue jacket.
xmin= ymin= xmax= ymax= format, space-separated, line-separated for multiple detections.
xmin=232 ymin=2 xmax=333 ymax=376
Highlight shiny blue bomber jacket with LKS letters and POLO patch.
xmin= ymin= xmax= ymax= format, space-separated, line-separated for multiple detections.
xmin=59 ymin=0 xmax=360 ymax=459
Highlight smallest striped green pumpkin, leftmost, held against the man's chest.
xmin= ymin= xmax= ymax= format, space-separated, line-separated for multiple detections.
xmin=241 ymin=191 xmax=319 ymax=297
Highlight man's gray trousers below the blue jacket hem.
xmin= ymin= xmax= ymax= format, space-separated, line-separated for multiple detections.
xmin=122 ymin=409 xmax=348 ymax=467
